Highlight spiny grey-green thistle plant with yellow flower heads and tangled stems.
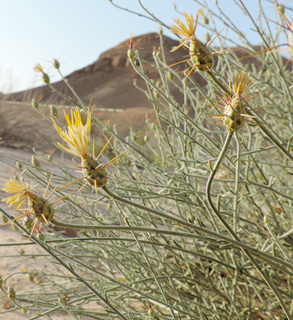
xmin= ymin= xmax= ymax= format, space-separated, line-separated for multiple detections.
xmin=0 ymin=0 xmax=293 ymax=320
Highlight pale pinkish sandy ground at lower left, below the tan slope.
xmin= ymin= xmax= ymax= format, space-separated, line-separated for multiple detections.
xmin=0 ymin=147 xmax=107 ymax=320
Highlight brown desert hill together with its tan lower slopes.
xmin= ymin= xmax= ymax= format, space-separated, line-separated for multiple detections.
xmin=0 ymin=33 xmax=264 ymax=150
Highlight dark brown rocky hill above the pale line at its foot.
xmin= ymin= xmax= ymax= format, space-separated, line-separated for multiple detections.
xmin=6 ymin=33 xmax=196 ymax=109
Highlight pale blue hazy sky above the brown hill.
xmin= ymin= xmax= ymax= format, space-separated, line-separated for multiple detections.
xmin=0 ymin=0 xmax=284 ymax=92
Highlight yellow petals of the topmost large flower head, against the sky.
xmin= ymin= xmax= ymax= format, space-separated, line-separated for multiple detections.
xmin=171 ymin=12 xmax=198 ymax=51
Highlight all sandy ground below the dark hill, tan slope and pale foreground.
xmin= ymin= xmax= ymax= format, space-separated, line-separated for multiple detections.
xmin=0 ymin=95 xmax=155 ymax=320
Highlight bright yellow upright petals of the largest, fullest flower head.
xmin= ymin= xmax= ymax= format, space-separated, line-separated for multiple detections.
xmin=52 ymin=108 xmax=91 ymax=159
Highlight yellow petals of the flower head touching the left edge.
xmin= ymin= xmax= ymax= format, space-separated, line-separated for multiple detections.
xmin=1 ymin=178 xmax=31 ymax=209
